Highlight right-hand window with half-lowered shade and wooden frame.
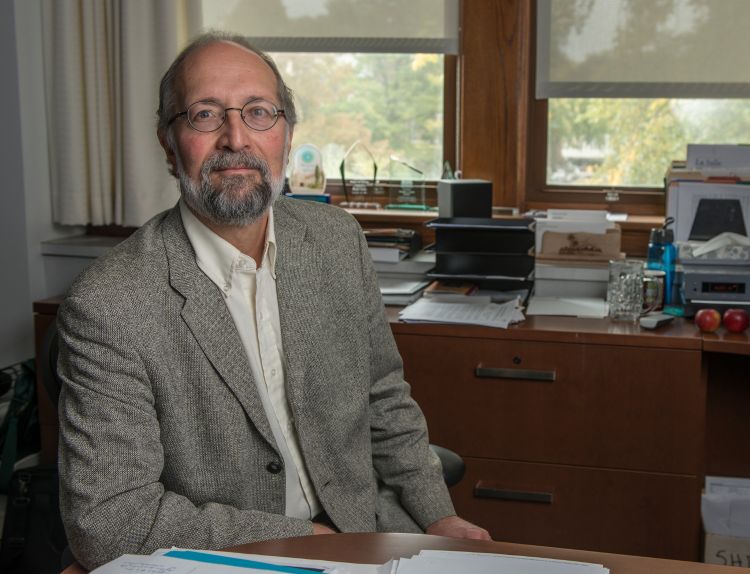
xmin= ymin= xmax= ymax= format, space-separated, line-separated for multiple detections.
xmin=527 ymin=0 xmax=750 ymax=212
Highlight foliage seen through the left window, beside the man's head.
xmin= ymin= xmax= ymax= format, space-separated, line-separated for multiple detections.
xmin=273 ymin=53 xmax=443 ymax=178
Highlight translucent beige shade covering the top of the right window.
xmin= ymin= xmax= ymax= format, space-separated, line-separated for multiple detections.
xmin=536 ymin=0 xmax=750 ymax=98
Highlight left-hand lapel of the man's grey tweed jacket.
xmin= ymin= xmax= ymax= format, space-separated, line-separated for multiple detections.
xmin=163 ymin=207 xmax=278 ymax=451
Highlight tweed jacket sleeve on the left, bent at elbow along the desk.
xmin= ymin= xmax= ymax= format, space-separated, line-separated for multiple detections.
xmin=58 ymin=296 xmax=312 ymax=569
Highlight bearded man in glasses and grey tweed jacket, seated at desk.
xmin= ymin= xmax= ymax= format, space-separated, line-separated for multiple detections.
xmin=58 ymin=34 xmax=489 ymax=568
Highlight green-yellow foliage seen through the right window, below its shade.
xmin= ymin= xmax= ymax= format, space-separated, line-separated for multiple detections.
xmin=547 ymin=98 xmax=750 ymax=187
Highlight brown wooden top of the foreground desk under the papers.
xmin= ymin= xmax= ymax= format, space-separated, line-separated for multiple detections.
xmin=229 ymin=533 xmax=747 ymax=574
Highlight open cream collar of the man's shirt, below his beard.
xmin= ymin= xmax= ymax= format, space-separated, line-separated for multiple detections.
xmin=179 ymin=199 xmax=276 ymax=296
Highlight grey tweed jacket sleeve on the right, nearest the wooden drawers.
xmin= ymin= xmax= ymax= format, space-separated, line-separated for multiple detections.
xmin=360 ymin=230 xmax=455 ymax=530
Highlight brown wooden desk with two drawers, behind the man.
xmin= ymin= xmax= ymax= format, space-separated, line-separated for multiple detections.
xmin=388 ymin=308 xmax=750 ymax=561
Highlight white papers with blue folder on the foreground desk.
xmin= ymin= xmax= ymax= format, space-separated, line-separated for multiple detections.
xmin=91 ymin=548 xmax=609 ymax=574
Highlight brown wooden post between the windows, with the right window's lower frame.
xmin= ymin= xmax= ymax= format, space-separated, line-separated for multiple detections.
xmin=458 ymin=0 xmax=666 ymax=216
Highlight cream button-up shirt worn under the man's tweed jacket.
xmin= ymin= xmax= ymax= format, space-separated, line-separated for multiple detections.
xmin=180 ymin=200 xmax=321 ymax=520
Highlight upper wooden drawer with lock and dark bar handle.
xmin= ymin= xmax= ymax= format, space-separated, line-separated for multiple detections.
xmin=397 ymin=335 xmax=705 ymax=474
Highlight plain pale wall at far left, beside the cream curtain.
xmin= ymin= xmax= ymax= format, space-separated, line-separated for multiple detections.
xmin=0 ymin=0 xmax=81 ymax=368
